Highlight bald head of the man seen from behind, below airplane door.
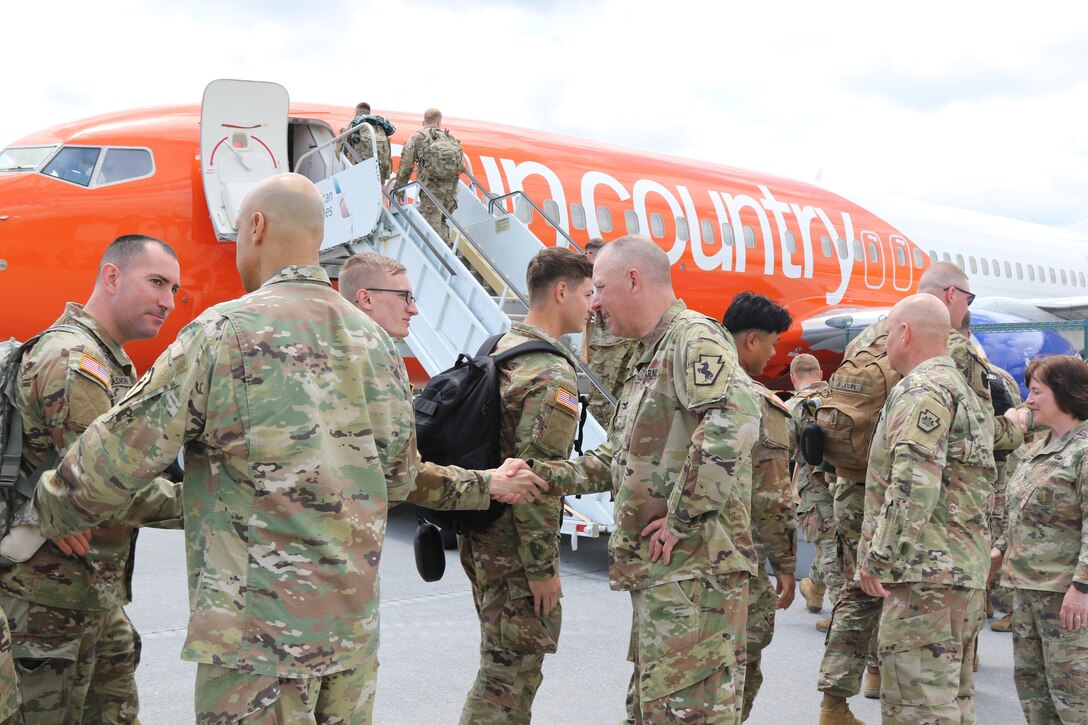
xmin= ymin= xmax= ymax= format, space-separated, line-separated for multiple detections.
xmin=236 ymin=173 xmax=324 ymax=292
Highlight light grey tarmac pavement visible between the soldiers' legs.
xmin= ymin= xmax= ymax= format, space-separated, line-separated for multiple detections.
xmin=127 ymin=506 xmax=1024 ymax=725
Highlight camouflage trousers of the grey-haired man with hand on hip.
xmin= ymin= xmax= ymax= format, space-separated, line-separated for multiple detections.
xmin=626 ymin=572 xmax=749 ymax=725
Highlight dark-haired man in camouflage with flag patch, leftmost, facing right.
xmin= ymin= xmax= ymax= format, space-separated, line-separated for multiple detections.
xmin=0 ymin=235 xmax=181 ymax=723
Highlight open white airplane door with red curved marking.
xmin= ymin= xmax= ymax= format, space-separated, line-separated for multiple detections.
xmin=200 ymin=78 xmax=289 ymax=242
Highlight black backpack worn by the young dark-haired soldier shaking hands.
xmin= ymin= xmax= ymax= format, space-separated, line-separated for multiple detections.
xmin=415 ymin=334 xmax=585 ymax=533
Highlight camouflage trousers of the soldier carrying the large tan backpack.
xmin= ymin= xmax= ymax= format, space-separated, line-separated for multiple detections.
xmin=816 ymin=478 xmax=882 ymax=698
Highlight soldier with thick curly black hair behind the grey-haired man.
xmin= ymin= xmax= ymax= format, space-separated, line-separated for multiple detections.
xmin=721 ymin=292 xmax=798 ymax=720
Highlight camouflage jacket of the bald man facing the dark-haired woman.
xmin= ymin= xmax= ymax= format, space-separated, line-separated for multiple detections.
xmin=858 ymin=356 xmax=996 ymax=589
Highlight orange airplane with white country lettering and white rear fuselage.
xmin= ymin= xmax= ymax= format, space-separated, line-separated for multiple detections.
xmin=0 ymin=82 xmax=1088 ymax=386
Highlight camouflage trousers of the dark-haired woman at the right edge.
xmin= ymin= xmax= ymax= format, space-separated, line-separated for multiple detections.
xmin=1013 ymin=589 xmax=1088 ymax=725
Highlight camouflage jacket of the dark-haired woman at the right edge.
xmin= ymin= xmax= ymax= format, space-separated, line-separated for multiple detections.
xmin=1001 ymin=421 xmax=1088 ymax=592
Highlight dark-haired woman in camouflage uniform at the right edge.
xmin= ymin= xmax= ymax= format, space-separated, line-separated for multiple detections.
xmin=992 ymin=356 xmax=1088 ymax=725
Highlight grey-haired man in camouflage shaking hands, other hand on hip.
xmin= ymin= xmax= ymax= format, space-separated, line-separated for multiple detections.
xmin=526 ymin=236 xmax=759 ymax=725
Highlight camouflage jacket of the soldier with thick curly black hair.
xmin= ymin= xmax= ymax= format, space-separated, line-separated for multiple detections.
xmin=752 ymin=382 xmax=798 ymax=574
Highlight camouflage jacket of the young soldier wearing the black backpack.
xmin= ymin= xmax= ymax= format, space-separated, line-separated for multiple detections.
xmin=495 ymin=322 xmax=579 ymax=580
